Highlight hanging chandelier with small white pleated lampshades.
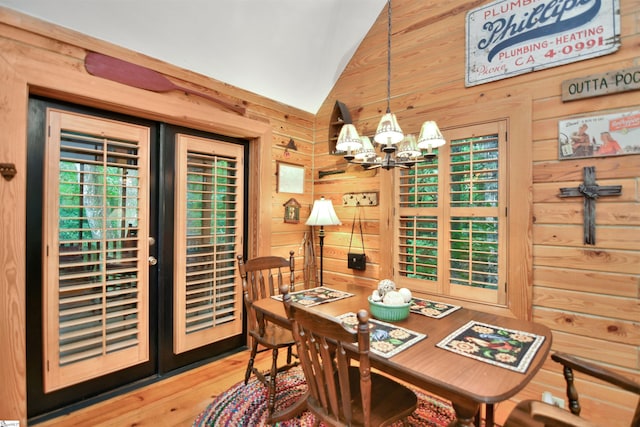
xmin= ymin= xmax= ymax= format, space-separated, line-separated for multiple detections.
xmin=336 ymin=0 xmax=446 ymax=170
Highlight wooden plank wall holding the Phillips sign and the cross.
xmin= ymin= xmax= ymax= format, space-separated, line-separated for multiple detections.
xmin=314 ymin=0 xmax=640 ymax=426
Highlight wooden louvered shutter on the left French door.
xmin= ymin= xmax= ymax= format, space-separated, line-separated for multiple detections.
xmin=43 ymin=110 xmax=149 ymax=392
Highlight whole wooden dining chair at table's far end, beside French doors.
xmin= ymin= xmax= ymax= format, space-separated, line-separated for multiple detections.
xmin=237 ymin=251 xmax=298 ymax=420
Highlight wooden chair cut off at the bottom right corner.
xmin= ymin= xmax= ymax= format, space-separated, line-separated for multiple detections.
xmin=504 ymin=353 xmax=640 ymax=427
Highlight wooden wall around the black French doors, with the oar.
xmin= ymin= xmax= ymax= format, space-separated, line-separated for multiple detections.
xmin=0 ymin=7 xmax=314 ymax=425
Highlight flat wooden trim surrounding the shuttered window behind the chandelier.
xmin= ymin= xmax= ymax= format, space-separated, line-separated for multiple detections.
xmin=380 ymin=97 xmax=533 ymax=320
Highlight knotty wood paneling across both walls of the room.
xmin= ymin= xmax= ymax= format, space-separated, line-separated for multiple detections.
xmin=0 ymin=0 xmax=640 ymax=425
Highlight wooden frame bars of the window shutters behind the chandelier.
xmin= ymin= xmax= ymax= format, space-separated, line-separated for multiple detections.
xmin=394 ymin=120 xmax=508 ymax=305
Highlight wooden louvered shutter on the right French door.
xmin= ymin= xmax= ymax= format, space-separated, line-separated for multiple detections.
xmin=174 ymin=135 xmax=244 ymax=353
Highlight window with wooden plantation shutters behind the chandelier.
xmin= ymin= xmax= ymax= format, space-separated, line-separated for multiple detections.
xmin=396 ymin=122 xmax=509 ymax=305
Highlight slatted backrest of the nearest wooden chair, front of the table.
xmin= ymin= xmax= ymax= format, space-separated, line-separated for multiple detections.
xmin=280 ymin=285 xmax=371 ymax=426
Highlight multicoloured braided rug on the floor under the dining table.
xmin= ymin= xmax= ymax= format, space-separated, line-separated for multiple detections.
xmin=193 ymin=368 xmax=455 ymax=427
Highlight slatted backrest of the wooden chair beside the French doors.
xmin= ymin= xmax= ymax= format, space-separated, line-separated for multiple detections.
xmin=237 ymin=251 xmax=295 ymax=328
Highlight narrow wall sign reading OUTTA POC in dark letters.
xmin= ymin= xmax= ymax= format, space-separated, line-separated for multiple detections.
xmin=562 ymin=67 xmax=640 ymax=102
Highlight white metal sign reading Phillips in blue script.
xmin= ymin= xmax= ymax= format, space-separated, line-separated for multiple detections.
xmin=465 ymin=0 xmax=620 ymax=87
